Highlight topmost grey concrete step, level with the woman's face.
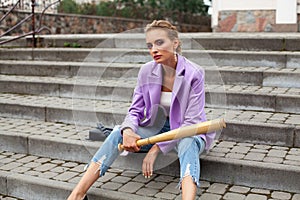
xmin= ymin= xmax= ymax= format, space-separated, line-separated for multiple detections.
xmin=1 ymin=31 xmax=300 ymax=51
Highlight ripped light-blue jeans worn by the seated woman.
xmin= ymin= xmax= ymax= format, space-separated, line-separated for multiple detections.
xmin=92 ymin=120 xmax=205 ymax=187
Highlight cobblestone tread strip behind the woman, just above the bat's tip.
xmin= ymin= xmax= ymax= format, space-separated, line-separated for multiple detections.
xmin=0 ymin=94 xmax=300 ymax=125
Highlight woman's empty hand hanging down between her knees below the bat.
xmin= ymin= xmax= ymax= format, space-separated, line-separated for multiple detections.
xmin=142 ymin=144 xmax=160 ymax=178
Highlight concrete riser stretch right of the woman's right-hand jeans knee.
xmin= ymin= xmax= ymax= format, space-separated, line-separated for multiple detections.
xmin=202 ymin=156 xmax=300 ymax=193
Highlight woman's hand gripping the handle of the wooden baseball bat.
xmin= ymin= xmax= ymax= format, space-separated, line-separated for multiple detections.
xmin=123 ymin=128 xmax=141 ymax=152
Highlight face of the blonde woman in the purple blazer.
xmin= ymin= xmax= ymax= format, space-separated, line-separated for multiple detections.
xmin=146 ymin=29 xmax=178 ymax=65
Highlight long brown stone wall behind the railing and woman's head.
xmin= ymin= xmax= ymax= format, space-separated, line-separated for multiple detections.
xmin=0 ymin=10 xmax=211 ymax=35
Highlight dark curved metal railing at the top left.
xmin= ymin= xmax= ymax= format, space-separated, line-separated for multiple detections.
xmin=0 ymin=0 xmax=61 ymax=47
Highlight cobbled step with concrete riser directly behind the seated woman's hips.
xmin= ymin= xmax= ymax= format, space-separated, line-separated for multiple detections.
xmin=0 ymin=94 xmax=300 ymax=147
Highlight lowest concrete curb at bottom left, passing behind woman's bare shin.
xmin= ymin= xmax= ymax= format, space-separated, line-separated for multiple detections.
xmin=0 ymin=172 xmax=153 ymax=200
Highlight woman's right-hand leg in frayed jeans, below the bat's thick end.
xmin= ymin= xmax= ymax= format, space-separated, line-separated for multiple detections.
xmin=178 ymin=136 xmax=205 ymax=200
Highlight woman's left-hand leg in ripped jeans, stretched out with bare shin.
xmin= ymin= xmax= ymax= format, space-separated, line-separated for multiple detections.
xmin=68 ymin=128 xmax=122 ymax=200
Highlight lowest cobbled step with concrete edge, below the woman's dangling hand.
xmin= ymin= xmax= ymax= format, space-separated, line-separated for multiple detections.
xmin=0 ymin=151 xmax=300 ymax=200
